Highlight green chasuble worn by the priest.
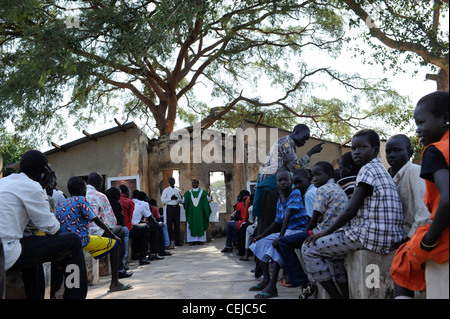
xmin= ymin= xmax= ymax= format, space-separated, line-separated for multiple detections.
xmin=183 ymin=188 xmax=211 ymax=236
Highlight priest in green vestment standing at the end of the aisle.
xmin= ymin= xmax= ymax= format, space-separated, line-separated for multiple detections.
xmin=183 ymin=179 xmax=211 ymax=245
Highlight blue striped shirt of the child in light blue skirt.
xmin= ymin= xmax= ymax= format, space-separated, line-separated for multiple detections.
xmin=275 ymin=189 xmax=308 ymax=230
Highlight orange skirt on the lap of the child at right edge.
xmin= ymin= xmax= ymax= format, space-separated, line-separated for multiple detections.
xmin=391 ymin=224 xmax=449 ymax=291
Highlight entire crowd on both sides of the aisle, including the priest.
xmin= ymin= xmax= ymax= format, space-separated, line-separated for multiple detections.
xmin=0 ymin=91 xmax=449 ymax=299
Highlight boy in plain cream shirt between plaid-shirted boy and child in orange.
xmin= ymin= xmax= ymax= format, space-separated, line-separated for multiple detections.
xmin=386 ymin=134 xmax=430 ymax=241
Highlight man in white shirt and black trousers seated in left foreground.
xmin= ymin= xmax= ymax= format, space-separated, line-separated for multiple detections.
xmin=0 ymin=150 xmax=87 ymax=299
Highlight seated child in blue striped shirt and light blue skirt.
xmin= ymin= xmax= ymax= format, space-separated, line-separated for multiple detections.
xmin=249 ymin=171 xmax=307 ymax=299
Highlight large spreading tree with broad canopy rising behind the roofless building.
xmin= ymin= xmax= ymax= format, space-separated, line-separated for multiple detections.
xmin=0 ymin=0 xmax=412 ymax=143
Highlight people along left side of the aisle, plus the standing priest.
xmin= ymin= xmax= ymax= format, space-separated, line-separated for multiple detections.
xmin=0 ymin=156 xmax=215 ymax=299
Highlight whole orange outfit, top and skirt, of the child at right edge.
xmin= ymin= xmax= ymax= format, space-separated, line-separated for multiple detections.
xmin=391 ymin=131 xmax=449 ymax=291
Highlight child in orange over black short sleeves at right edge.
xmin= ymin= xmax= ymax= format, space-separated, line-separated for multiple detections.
xmin=391 ymin=91 xmax=449 ymax=298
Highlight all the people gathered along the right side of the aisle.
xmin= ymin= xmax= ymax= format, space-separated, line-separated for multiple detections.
xmin=222 ymin=91 xmax=449 ymax=299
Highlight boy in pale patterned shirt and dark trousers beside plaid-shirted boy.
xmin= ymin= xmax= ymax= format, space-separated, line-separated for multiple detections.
xmin=278 ymin=162 xmax=348 ymax=299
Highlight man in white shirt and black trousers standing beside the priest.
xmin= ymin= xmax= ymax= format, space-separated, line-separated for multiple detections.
xmin=161 ymin=177 xmax=183 ymax=246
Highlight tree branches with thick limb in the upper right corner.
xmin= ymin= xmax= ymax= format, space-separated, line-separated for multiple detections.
xmin=335 ymin=0 xmax=450 ymax=91
